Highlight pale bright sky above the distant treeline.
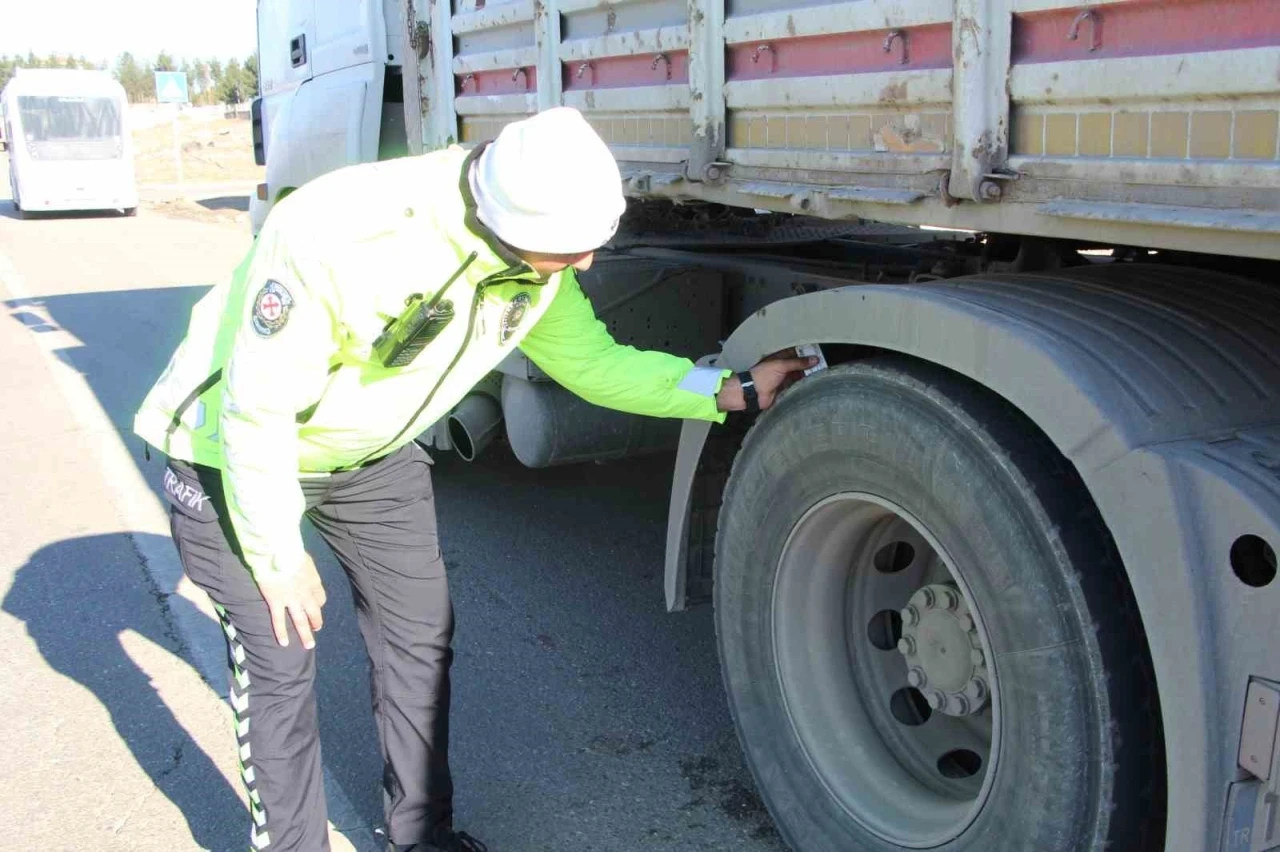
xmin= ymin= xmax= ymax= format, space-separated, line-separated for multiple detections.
xmin=0 ymin=0 xmax=257 ymax=61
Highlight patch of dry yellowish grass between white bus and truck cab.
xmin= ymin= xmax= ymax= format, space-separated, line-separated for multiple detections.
xmin=133 ymin=118 xmax=265 ymax=184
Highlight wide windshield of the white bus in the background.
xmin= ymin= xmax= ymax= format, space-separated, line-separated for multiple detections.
xmin=18 ymin=96 xmax=123 ymax=160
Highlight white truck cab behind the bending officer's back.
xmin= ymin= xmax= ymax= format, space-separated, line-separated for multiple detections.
xmin=250 ymin=0 xmax=404 ymax=234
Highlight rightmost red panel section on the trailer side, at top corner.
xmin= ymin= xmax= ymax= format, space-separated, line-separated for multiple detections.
xmin=1012 ymin=0 xmax=1280 ymax=64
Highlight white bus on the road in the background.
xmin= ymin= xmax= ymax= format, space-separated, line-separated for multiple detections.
xmin=0 ymin=68 xmax=138 ymax=216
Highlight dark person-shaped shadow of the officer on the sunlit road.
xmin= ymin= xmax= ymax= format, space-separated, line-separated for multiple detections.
xmin=0 ymin=533 xmax=246 ymax=849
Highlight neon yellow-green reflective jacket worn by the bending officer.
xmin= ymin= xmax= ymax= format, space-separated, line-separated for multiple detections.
xmin=134 ymin=148 xmax=723 ymax=576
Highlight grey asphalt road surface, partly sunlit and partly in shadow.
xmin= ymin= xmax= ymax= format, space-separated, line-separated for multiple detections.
xmin=0 ymin=179 xmax=782 ymax=852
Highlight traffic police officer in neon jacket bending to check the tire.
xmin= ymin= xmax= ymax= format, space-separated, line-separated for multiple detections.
xmin=134 ymin=109 xmax=806 ymax=852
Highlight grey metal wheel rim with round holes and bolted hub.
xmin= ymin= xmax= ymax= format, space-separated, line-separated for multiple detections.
xmin=772 ymin=493 xmax=1000 ymax=848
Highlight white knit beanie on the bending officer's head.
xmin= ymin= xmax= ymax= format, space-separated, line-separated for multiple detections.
xmin=471 ymin=106 xmax=626 ymax=255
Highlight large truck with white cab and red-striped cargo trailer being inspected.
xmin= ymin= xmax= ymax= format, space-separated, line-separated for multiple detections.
xmin=253 ymin=0 xmax=1280 ymax=852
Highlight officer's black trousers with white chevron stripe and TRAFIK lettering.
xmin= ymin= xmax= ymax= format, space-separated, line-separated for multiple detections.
xmin=164 ymin=443 xmax=453 ymax=852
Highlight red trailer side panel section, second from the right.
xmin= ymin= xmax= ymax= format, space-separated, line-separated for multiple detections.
xmin=724 ymin=23 xmax=951 ymax=81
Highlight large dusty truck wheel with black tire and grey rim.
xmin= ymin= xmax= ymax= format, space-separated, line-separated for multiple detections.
xmin=714 ymin=356 xmax=1165 ymax=852
